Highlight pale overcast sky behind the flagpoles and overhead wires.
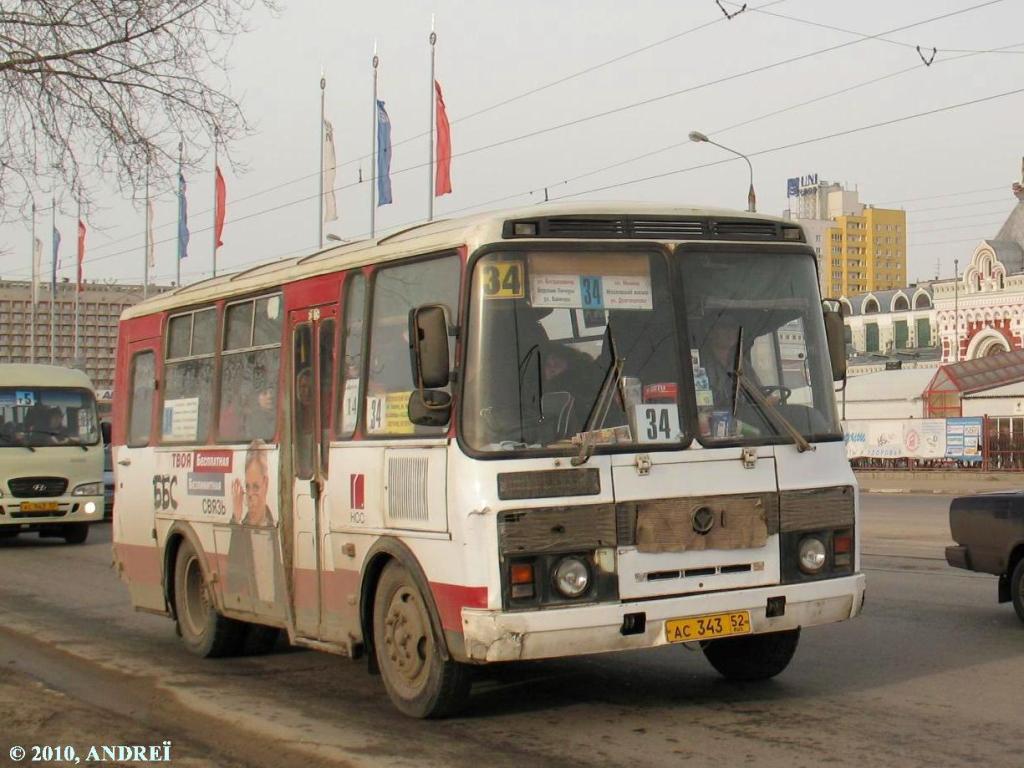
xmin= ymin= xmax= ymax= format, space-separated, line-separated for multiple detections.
xmin=0 ymin=0 xmax=1024 ymax=284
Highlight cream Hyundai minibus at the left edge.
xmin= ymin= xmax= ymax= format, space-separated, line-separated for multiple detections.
xmin=0 ymin=365 xmax=103 ymax=544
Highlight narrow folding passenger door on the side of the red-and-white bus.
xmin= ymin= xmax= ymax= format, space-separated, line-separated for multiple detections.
xmin=290 ymin=304 xmax=338 ymax=639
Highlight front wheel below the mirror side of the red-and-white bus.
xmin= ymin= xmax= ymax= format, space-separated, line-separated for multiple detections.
xmin=374 ymin=561 xmax=470 ymax=718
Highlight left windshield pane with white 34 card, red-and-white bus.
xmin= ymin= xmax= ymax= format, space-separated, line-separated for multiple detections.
xmin=462 ymin=249 xmax=687 ymax=452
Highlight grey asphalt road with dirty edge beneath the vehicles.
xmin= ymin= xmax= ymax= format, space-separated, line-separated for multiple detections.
xmin=0 ymin=495 xmax=1024 ymax=768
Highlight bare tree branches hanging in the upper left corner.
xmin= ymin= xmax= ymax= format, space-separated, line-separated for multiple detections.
xmin=0 ymin=0 xmax=276 ymax=221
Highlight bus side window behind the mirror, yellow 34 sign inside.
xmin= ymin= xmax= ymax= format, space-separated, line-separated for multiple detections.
xmin=366 ymin=254 xmax=461 ymax=435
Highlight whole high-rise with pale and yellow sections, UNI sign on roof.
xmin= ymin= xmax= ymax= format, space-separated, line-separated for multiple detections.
xmin=786 ymin=181 xmax=906 ymax=297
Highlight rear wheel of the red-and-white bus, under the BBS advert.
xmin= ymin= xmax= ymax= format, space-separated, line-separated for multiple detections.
xmin=174 ymin=539 xmax=245 ymax=658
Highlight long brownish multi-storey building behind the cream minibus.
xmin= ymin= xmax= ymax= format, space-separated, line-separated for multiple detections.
xmin=0 ymin=281 xmax=167 ymax=393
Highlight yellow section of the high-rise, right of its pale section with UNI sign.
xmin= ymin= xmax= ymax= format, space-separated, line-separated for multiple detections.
xmin=820 ymin=206 xmax=906 ymax=297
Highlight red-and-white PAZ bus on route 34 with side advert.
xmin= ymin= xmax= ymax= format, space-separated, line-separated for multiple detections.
xmin=114 ymin=205 xmax=864 ymax=717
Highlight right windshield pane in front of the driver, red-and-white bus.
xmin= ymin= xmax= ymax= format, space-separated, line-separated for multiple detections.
xmin=680 ymin=251 xmax=842 ymax=444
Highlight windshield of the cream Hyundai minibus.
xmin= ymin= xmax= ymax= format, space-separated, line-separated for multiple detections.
xmin=0 ymin=386 xmax=99 ymax=447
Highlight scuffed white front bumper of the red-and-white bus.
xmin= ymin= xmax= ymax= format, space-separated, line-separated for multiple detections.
xmin=462 ymin=573 xmax=864 ymax=663
